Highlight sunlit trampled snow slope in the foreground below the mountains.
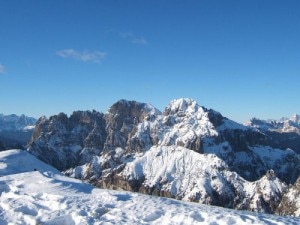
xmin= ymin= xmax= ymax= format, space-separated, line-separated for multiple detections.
xmin=0 ymin=150 xmax=300 ymax=225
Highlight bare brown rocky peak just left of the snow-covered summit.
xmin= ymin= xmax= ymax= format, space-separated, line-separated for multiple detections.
xmin=103 ymin=100 xmax=161 ymax=152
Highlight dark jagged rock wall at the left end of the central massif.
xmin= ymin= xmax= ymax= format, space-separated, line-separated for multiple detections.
xmin=29 ymin=111 xmax=106 ymax=170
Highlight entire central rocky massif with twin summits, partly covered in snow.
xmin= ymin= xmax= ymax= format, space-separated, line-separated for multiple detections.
xmin=28 ymin=99 xmax=300 ymax=213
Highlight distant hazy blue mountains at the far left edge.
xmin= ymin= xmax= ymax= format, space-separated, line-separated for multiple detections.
xmin=0 ymin=114 xmax=36 ymax=151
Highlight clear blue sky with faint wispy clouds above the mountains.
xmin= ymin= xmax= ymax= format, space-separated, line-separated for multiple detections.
xmin=0 ymin=0 xmax=300 ymax=122
